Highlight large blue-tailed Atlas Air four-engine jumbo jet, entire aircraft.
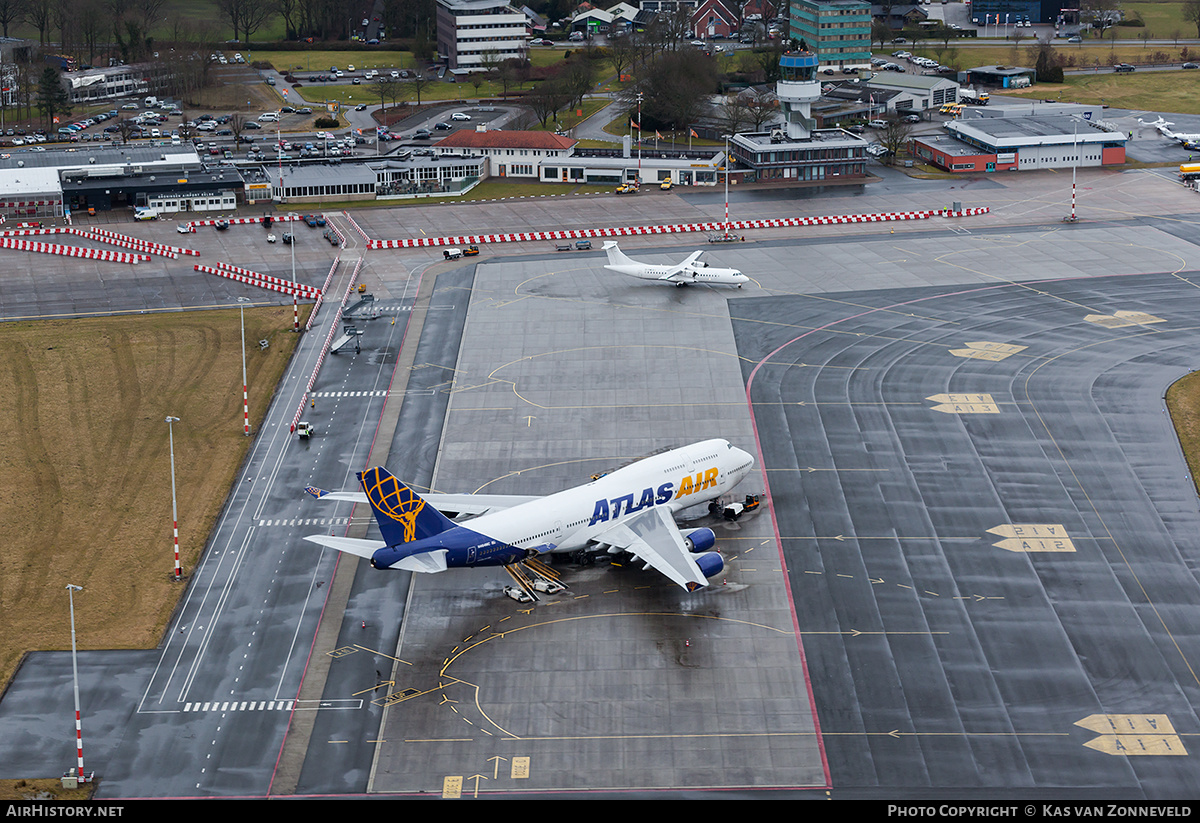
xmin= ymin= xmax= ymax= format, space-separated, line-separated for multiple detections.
xmin=305 ymin=440 xmax=754 ymax=591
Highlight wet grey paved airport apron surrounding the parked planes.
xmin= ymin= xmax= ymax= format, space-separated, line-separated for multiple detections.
xmin=7 ymin=163 xmax=1200 ymax=800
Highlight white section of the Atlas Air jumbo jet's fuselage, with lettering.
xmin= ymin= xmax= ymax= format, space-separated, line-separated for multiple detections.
xmin=463 ymin=439 xmax=754 ymax=552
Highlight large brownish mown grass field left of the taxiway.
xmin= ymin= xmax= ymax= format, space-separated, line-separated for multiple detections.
xmin=0 ymin=306 xmax=304 ymax=683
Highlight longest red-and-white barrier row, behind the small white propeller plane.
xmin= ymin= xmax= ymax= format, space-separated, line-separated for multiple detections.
xmin=367 ymin=208 xmax=989 ymax=248
